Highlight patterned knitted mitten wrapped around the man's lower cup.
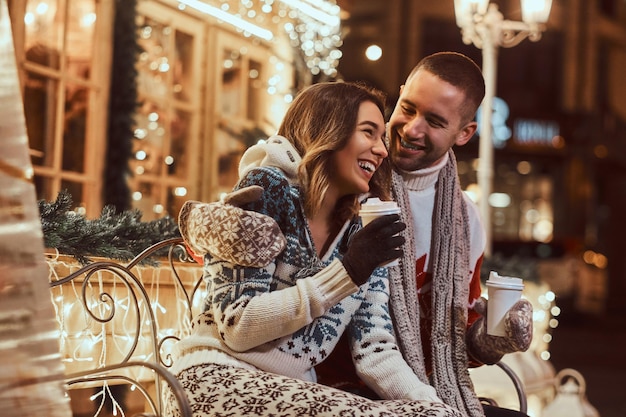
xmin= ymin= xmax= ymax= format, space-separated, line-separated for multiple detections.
xmin=467 ymin=297 xmax=533 ymax=365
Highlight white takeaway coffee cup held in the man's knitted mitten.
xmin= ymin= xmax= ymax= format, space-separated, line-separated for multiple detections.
xmin=487 ymin=271 xmax=524 ymax=336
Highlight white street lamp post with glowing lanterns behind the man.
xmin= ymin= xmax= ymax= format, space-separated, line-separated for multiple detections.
xmin=454 ymin=0 xmax=552 ymax=256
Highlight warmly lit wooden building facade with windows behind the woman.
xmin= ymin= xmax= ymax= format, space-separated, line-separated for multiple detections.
xmin=8 ymin=0 xmax=341 ymax=216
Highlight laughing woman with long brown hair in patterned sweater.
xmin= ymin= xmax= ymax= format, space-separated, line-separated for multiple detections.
xmin=167 ymin=83 xmax=454 ymax=416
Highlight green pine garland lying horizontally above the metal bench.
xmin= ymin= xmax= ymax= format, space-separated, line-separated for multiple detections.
xmin=39 ymin=190 xmax=180 ymax=264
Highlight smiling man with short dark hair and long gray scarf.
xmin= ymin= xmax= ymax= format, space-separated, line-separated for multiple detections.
xmin=317 ymin=52 xmax=532 ymax=417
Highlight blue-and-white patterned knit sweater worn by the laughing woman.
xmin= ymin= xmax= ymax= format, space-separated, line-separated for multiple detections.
xmin=173 ymin=137 xmax=408 ymax=380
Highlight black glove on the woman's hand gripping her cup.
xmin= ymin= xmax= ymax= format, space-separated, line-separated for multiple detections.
xmin=342 ymin=214 xmax=406 ymax=285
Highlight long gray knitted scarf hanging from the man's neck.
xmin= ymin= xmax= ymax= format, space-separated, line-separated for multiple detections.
xmin=390 ymin=150 xmax=484 ymax=417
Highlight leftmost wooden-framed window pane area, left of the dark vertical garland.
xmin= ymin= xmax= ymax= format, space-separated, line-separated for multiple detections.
xmin=9 ymin=0 xmax=112 ymax=214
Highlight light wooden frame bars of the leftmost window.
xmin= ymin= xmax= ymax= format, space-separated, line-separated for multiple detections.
xmin=8 ymin=0 xmax=114 ymax=217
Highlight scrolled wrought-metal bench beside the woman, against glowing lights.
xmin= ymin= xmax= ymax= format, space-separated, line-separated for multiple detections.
xmin=47 ymin=238 xmax=202 ymax=417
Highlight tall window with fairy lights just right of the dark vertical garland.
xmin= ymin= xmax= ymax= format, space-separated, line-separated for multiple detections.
xmin=129 ymin=2 xmax=204 ymax=219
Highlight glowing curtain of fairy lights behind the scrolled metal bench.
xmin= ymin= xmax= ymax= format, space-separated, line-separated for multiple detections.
xmin=47 ymin=255 xmax=205 ymax=417
